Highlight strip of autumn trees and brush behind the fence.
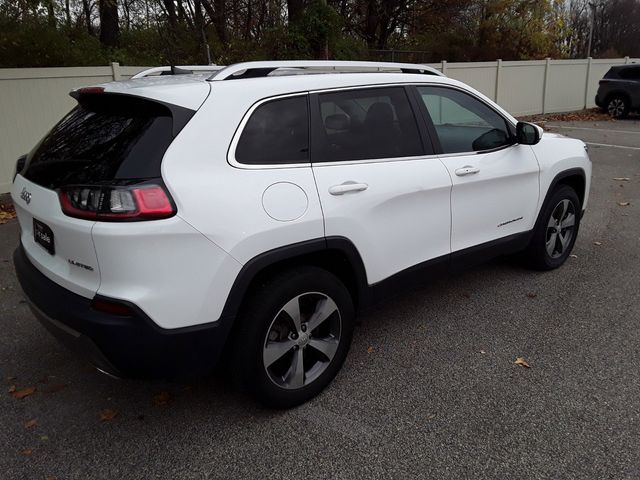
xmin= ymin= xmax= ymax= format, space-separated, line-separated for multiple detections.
xmin=0 ymin=0 xmax=640 ymax=67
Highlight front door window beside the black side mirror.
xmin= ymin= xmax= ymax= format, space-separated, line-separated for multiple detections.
xmin=418 ymin=87 xmax=513 ymax=153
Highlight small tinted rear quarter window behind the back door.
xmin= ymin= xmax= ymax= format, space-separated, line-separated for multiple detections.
xmin=236 ymin=95 xmax=309 ymax=165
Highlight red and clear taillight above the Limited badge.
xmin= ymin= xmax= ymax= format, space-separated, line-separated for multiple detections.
xmin=59 ymin=185 xmax=176 ymax=222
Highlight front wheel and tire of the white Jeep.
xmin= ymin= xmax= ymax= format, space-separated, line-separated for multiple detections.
xmin=525 ymin=185 xmax=581 ymax=270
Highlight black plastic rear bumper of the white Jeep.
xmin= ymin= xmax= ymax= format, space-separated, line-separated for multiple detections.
xmin=13 ymin=246 xmax=232 ymax=378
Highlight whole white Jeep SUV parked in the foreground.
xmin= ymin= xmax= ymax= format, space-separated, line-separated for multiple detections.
xmin=12 ymin=62 xmax=591 ymax=407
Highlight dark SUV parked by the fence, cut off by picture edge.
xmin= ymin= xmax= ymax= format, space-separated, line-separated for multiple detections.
xmin=596 ymin=64 xmax=640 ymax=118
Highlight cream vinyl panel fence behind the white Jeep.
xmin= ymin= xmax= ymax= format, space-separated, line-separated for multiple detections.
xmin=0 ymin=57 xmax=634 ymax=193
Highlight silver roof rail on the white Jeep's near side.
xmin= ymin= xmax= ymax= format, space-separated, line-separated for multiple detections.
xmin=207 ymin=60 xmax=444 ymax=81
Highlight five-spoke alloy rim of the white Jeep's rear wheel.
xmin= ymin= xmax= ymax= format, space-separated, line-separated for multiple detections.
xmin=262 ymin=292 xmax=342 ymax=389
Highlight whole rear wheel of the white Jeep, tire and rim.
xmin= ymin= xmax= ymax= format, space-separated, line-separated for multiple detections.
xmin=230 ymin=266 xmax=355 ymax=408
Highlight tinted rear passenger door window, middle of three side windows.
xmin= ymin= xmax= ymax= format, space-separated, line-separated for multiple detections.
xmin=314 ymin=87 xmax=424 ymax=162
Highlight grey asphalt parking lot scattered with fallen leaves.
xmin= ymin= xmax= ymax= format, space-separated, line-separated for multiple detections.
xmin=0 ymin=119 xmax=640 ymax=480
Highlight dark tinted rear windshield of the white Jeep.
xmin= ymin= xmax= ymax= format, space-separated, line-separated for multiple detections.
xmin=23 ymin=94 xmax=193 ymax=189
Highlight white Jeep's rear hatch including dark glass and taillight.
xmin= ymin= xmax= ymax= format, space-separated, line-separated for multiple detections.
xmin=12 ymin=81 xmax=208 ymax=298
